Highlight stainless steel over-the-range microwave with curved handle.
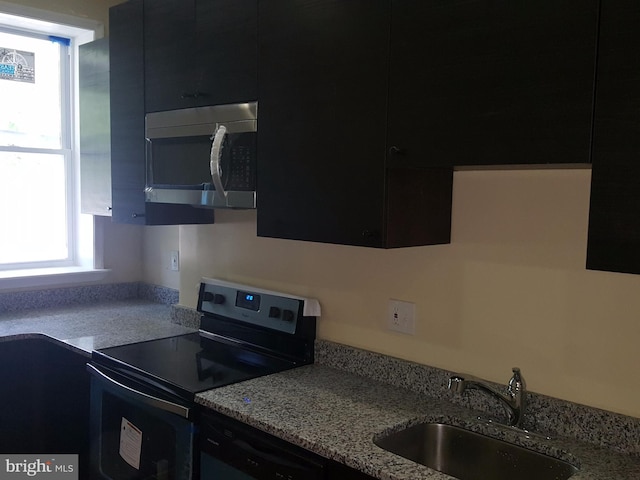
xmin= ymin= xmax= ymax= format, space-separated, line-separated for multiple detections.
xmin=145 ymin=102 xmax=258 ymax=208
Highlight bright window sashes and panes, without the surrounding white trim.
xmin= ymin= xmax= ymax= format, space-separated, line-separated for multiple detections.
xmin=0 ymin=28 xmax=74 ymax=268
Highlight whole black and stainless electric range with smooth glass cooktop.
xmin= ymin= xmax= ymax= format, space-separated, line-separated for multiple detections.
xmin=88 ymin=278 xmax=320 ymax=480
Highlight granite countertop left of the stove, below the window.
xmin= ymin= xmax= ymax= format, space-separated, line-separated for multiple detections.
xmin=0 ymin=299 xmax=197 ymax=356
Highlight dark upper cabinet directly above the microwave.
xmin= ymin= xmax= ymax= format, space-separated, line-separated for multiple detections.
xmin=144 ymin=0 xmax=258 ymax=112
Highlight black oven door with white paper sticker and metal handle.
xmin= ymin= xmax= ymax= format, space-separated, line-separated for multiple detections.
xmin=87 ymin=364 xmax=195 ymax=480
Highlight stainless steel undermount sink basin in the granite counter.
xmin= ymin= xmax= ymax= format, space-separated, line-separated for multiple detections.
xmin=374 ymin=423 xmax=578 ymax=480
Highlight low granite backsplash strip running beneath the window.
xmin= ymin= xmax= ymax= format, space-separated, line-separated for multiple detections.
xmin=0 ymin=282 xmax=179 ymax=313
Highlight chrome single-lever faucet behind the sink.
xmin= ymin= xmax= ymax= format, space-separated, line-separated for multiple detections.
xmin=449 ymin=367 xmax=526 ymax=428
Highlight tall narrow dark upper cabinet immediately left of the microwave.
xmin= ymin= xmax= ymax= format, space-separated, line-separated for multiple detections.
xmin=109 ymin=0 xmax=213 ymax=225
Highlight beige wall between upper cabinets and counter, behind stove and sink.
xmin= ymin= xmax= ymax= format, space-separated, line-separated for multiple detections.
xmin=154 ymin=170 xmax=640 ymax=417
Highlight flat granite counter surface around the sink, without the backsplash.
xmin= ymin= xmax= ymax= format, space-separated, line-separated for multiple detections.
xmin=196 ymin=352 xmax=640 ymax=480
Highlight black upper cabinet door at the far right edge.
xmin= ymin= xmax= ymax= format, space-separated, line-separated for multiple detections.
xmin=587 ymin=0 xmax=640 ymax=273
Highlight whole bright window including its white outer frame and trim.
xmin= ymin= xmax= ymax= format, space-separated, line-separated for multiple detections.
xmin=0 ymin=6 xmax=101 ymax=284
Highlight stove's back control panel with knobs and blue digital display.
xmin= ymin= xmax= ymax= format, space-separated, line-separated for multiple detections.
xmin=198 ymin=278 xmax=320 ymax=334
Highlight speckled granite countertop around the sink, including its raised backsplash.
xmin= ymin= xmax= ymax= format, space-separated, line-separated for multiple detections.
xmin=196 ymin=341 xmax=640 ymax=480
